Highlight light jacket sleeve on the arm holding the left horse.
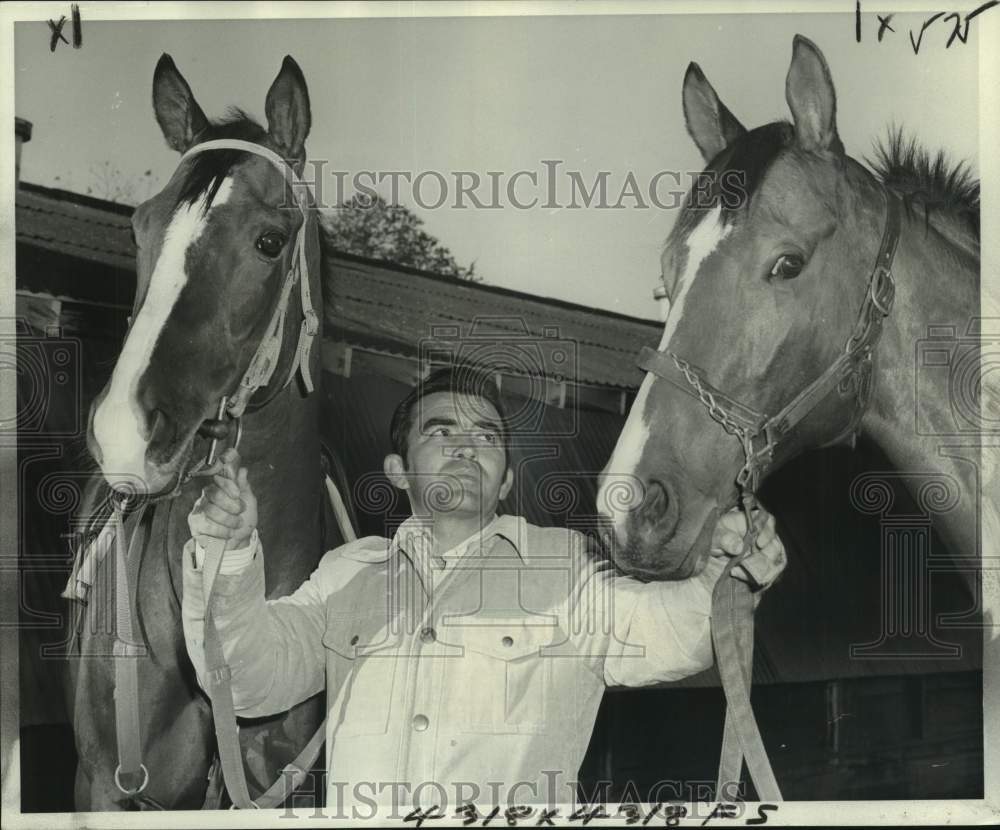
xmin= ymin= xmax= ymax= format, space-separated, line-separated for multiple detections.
xmin=181 ymin=540 xmax=326 ymax=717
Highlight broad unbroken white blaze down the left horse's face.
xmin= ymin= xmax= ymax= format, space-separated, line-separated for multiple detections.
xmin=94 ymin=178 xmax=233 ymax=485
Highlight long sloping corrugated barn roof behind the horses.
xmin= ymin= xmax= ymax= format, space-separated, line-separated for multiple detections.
xmin=16 ymin=184 xmax=661 ymax=389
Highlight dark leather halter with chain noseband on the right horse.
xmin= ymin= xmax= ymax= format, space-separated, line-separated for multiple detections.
xmin=637 ymin=190 xmax=901 ymax=492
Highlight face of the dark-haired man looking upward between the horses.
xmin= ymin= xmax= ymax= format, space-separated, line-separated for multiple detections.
xmin=387 ymin=392 xmax=513 ymax=518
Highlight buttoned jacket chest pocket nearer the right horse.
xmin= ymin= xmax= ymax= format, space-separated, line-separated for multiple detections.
xmin=441 ymin=617 xmax=557 ymax=735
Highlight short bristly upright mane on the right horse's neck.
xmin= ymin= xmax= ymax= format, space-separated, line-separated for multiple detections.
xmin=865 ymin=126 xmax=979 ymax=240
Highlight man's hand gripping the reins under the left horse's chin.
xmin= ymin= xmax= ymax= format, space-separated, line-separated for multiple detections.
xmin=188 ymin=449 xmax=257 ymax=550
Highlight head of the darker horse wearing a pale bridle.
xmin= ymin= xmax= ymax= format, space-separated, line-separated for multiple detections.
xmin=87 ymin=55 xmax=319 ymax=495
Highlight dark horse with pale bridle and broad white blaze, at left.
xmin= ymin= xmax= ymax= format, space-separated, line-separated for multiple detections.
xmin=69 ymin=55 xmax=344 ymax=810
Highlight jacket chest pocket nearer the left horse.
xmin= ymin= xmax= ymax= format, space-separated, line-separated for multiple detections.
xmin=323 ymin=618 xmax=397 ymax=738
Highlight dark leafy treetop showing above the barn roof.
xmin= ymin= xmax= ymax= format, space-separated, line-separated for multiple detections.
xmin=322 ymin=194 xmax=482 ymax=282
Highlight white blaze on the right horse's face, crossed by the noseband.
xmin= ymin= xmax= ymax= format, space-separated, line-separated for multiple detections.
xmin=597 ymin=207 xmax=732 ymax=543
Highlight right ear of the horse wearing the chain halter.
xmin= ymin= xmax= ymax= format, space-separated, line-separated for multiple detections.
xmin=785 ymin=35 xmax=844 ymax=153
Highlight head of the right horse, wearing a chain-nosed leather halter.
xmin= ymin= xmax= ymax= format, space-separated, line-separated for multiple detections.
xmin=598 ymin=36 xmax=887 ymax=578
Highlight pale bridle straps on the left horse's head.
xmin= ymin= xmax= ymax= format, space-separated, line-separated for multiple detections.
xmin=181 ymin=138 xmax=319 ymax=418
